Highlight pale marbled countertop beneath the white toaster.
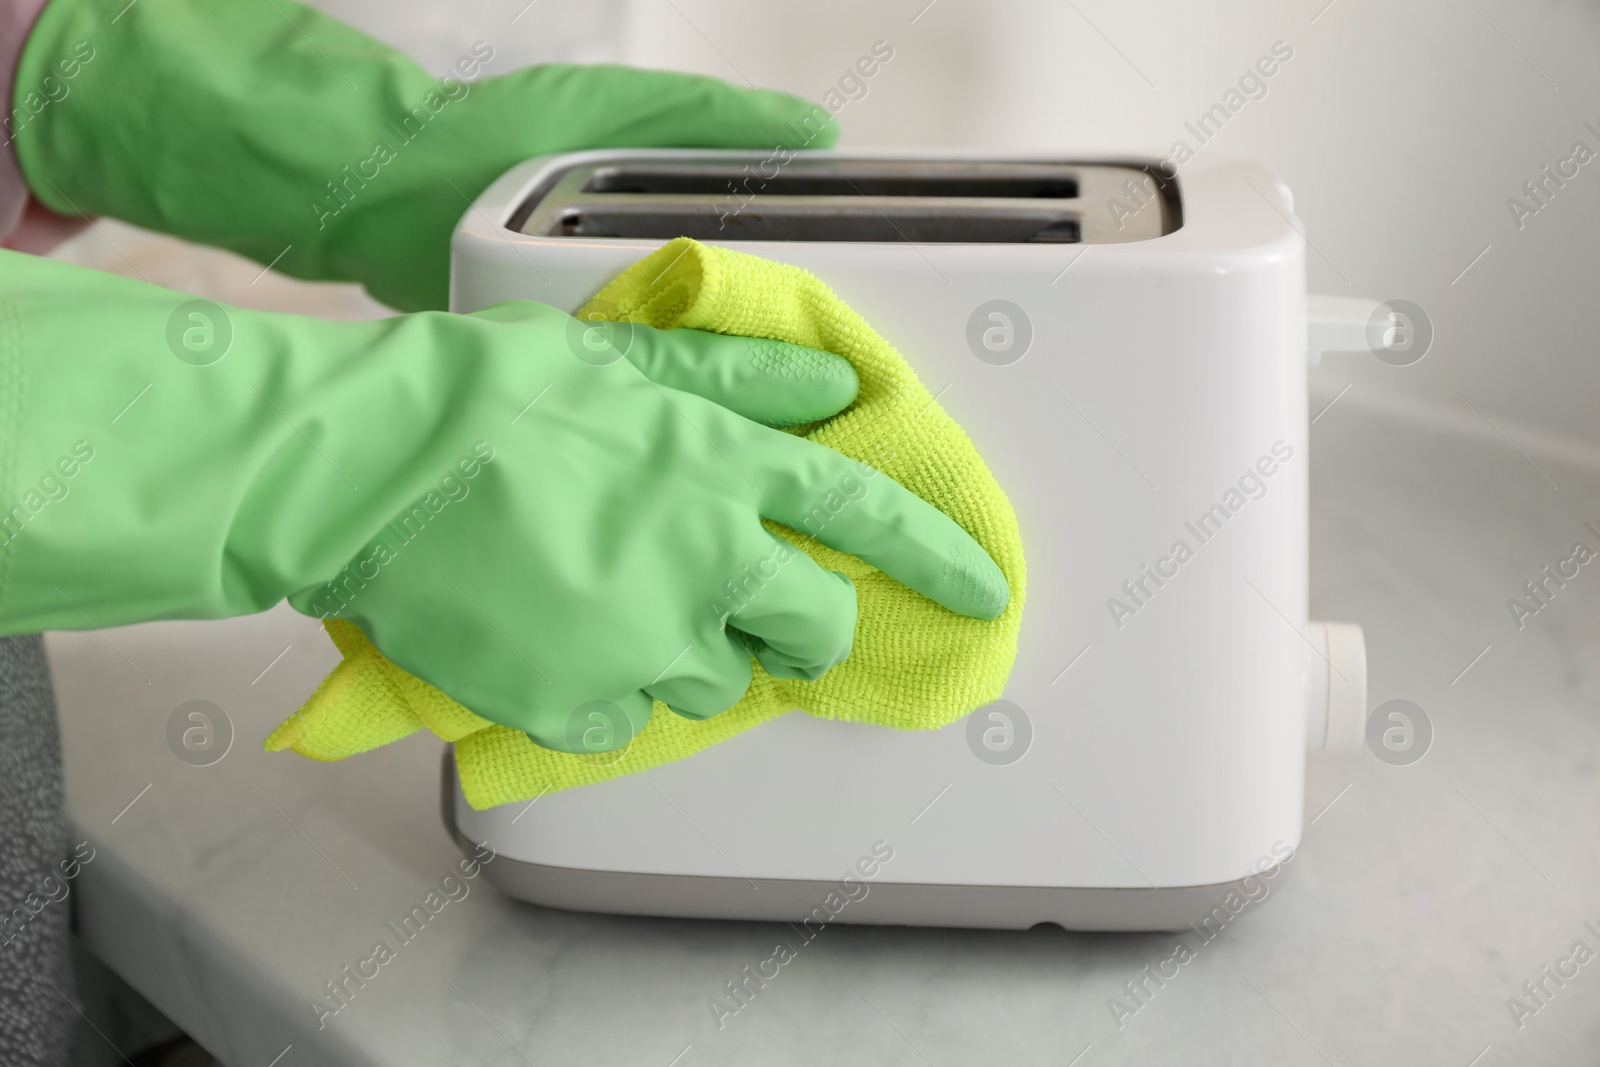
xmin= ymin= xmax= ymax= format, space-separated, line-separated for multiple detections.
xmin=48 ymin=399 xmax=1600 ymax=1067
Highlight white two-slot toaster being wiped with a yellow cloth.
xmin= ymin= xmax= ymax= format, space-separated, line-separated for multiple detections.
xmin=443 ymin=150 xmax=1378 ymax=929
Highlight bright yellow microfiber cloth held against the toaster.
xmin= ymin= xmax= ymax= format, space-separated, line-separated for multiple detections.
xmin=266 ymin=238 xmax=1024 ymax=809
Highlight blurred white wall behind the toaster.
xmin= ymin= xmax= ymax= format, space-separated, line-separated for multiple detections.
xmin=243 ymin=0 xmax=1600 ymax=461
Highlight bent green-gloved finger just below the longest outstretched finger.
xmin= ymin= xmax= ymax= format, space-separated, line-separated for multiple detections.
xmin=718 ymin=530 xmax=856 ymax=680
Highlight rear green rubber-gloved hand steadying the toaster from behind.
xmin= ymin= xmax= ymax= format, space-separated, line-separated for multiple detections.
xmin=14 ymin=0 xmax=837 ymax=310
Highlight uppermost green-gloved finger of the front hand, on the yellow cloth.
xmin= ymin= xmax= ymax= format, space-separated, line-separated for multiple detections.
xmin=610 ymin=325 xmax=859 ymax=426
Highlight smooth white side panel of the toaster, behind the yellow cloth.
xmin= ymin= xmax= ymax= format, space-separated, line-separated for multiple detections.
xmin=454 ymin=154 xmax=1309 ymax=888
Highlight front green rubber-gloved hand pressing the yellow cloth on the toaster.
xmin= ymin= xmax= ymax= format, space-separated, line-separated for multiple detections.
xmin=0 ymin=254 xmax=1008 ymax=750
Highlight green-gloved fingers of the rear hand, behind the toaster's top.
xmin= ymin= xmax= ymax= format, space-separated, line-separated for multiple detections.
xmin=512 ymin=64 xmax=838 ymax=152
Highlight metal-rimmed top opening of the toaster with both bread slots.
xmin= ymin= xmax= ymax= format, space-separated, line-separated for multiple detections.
xmin=509 ymin=152 xmax=1181 ymax=245
